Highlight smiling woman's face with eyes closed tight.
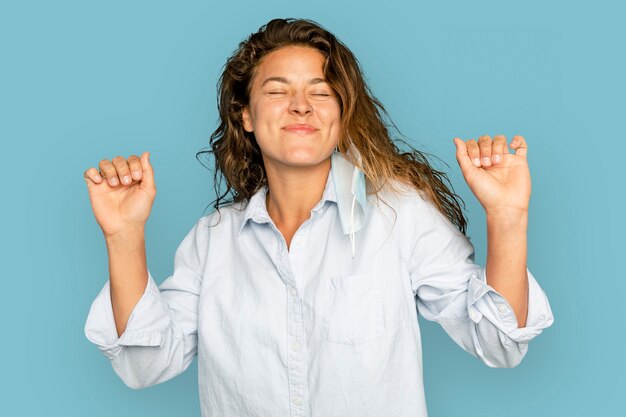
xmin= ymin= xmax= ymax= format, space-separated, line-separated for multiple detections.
xmin=242 ymin=46 xmax=341 ymax=172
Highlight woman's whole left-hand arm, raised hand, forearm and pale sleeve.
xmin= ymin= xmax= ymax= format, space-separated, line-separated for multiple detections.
xmin=84 ymin=152 xmax=200 ymax=388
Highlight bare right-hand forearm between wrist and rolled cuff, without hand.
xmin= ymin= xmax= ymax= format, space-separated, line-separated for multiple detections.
xmin=486 ymin=211 xmax=528 ymax=327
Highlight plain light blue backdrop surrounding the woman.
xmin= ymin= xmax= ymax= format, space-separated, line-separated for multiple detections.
xmin=0 ymin=0 xmax=626 ymax=417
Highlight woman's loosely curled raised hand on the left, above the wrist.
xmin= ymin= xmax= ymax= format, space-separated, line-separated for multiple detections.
xmin=84 ymin=152 xmax=156 ymax=237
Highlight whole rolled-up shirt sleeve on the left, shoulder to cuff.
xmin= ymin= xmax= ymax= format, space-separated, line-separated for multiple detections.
xmin=85 ymin=221 xmax=208 ymax=388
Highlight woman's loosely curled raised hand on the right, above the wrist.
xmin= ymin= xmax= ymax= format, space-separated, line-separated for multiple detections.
xmin=454 ymin=135 xmax=531 ymax=215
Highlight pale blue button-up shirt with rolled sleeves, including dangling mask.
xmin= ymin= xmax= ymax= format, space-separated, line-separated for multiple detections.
xmin=85 ymin=154 xmax=554 ymax=417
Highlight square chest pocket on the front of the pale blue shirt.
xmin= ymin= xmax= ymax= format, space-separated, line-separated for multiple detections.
xmin=323 ymin=275 xmax=385 ymax=345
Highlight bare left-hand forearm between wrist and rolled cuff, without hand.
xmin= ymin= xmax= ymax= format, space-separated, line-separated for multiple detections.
xmin=105 ymin=228 xmax=148 ymax=337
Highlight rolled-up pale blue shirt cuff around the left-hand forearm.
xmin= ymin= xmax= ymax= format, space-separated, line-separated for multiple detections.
xmin=85 ymin=271 xmax=170 ymax=358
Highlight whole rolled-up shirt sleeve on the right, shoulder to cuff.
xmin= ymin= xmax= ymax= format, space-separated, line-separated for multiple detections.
xmin=410 ymin=200 xmax=554 ymax=368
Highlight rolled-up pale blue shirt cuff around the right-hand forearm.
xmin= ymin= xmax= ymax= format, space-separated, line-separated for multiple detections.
xmin=467 ymin=268 xmax=554 ymax=343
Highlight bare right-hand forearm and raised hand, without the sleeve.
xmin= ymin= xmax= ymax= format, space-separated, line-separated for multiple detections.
xmin=454 ymin=135 xmax=531 ymax=327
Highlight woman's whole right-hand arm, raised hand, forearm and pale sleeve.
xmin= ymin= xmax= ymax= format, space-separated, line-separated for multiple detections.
xmin=410 ymin=136 xmax=554 ymax=367
